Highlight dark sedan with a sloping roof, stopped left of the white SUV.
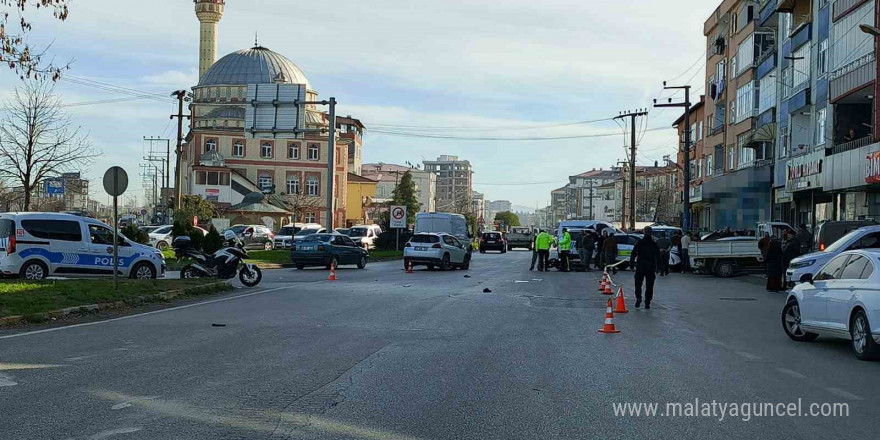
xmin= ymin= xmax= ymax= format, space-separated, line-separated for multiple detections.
xmin=290 ymin=233 xmax=369 ymax=269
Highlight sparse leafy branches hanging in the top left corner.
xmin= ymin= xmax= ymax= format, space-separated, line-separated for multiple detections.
xmin=0 ymin=0 xmax=70 ymax=80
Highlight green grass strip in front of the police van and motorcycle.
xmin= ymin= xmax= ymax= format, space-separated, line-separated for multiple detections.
xmin=0 ymin=279 xmax=232 ymax=322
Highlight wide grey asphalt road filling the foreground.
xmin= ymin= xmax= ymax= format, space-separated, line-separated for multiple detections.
xmin=0 ymin=252 xmax=880 ymax=440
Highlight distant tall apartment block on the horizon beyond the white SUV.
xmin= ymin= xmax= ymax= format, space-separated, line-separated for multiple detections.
xmin=423 ymin=155 xmax=474 ymax=213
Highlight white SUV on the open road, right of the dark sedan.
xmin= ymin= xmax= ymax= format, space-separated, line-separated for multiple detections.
xmin=403 ymin=233 xmax=471 ymax=270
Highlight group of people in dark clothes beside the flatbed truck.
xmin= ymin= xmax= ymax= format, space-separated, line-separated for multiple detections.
xmin=758 ymin=224 xmax=813 ymax=292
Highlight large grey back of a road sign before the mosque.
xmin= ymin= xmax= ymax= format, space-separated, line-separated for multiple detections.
xmin=244 ymin=84 xmax=306 ymax=139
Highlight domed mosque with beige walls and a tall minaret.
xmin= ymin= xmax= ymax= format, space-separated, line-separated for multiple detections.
xmin=181 ymin=0 xmax=364 ymax=230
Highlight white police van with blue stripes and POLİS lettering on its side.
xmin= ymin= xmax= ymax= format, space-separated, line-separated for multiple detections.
xmin=0 ymin=212 xmax=165 ymax=280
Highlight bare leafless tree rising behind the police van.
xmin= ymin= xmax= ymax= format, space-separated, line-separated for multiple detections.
xmin=0 ymin=81 xmax=98 ymax=211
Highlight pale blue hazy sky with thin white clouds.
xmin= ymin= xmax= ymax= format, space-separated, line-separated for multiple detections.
xmin=0 ymin=0 xmax=717 ymax=207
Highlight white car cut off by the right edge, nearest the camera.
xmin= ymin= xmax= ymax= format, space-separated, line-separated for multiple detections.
xmin=782 ymin=250 xmax=880 ymax=360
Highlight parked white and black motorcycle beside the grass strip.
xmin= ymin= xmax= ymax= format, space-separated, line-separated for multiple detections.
xmin=171 ymin=231 xmax=263 ymax=287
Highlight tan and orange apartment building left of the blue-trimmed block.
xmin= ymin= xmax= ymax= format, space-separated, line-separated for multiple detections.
xmin=694 ymin=0 xmax=777 ymax=229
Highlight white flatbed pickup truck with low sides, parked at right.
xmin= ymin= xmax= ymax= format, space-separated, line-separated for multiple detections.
xmin=688 ymin=222 xmax=794 ymax=278
